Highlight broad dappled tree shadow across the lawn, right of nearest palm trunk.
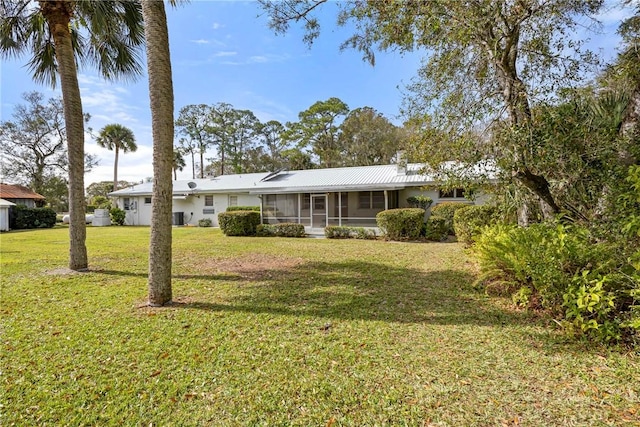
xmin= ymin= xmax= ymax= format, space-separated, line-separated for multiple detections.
xmin=166 ymin=260 xmax=532 ymax=326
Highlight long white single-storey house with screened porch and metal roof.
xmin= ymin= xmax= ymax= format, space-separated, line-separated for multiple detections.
xmin=109 ymin=164 xmax=485 ymax=229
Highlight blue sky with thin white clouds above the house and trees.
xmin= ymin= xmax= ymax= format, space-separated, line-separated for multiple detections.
xmin=0 ymin=1 xmax=627 ymax=185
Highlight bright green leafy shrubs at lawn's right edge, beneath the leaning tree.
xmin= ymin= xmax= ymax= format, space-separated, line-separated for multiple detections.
xmin=474 ymin=224 xmax=640 ymax=342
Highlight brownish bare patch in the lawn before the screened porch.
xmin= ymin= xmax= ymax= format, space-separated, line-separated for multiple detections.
xmin=185 ymin=253 xmax=304 ymax=280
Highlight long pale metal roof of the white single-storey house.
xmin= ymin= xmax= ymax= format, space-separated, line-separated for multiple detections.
xmin=109 ymin=163 xmax=496 ymax=196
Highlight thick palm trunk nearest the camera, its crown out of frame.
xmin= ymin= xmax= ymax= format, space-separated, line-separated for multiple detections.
xmin=142 ymin=0 xmax=174 ymax=307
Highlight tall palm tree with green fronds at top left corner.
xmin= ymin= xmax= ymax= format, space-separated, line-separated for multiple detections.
xmin=0 ymin=0 xmax=144 ymax=270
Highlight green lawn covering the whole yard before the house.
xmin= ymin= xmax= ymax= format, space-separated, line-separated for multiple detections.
xmin=0 ymin=227 xmax=640 ymax=426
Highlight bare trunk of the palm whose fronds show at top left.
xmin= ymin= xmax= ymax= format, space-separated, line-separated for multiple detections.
xmin=40 ymin=0 xmax=88 ymax=270
